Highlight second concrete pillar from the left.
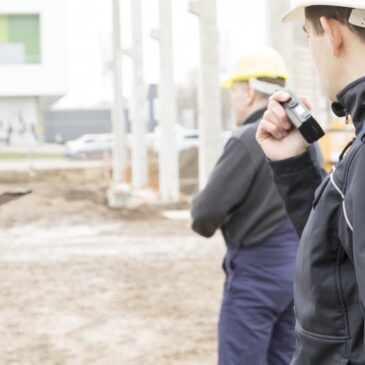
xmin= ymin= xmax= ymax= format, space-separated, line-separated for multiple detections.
xmin=130 ymin=0 xmax=148 ymax=189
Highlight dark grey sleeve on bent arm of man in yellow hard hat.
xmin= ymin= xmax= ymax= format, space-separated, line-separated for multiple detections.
xmin=191 ymin=137 xmax=255 ymax=237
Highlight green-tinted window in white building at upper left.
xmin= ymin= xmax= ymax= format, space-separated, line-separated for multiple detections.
xmin=0 ymin=14 xmax=41 ymax=64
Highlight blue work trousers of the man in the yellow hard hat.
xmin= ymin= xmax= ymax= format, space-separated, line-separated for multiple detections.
xmin=218 ymin=220 xmax=299 ymax=365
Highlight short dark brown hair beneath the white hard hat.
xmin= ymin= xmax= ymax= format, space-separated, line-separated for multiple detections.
xmin=305 ymin=5 xmax=365 ymax=42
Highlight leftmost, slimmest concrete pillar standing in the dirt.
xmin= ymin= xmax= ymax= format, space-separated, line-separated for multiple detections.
xmin=108 ymin=0 xmax=127 ymax=208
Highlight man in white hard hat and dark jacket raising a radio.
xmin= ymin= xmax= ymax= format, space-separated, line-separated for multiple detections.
xmin=257 ymin=0 xmax=365 ymax=365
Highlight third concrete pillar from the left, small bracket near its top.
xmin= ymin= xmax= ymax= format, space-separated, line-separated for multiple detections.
xmin=153 ymin=0 xmax=180 ymax=203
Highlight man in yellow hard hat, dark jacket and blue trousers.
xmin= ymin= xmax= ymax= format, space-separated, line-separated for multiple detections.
xmin=192 ymin=48 xmax=298 ymax=365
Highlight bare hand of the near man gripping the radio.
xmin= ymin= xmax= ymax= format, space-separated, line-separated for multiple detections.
xmin=256 ymin=91 xmax=311 ymax=161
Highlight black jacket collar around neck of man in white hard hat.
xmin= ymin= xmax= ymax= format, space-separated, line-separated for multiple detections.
xmin=332 ymin=77 xmax=365 ymax=134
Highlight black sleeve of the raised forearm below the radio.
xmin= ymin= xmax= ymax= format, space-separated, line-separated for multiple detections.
xmin=269 ymin=146 xmax=326 ymax=236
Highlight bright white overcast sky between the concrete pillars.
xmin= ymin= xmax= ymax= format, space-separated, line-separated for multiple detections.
xmin=61 ymin=0 xmax=266 ymax=107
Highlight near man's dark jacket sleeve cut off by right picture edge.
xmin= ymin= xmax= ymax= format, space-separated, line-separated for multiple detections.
xmin=343 ymin=145 xmax=365 ymax=311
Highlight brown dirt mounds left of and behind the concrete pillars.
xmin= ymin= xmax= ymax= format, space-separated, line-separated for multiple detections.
xmin=0 ymin=148 xmax=198 ymax=227
